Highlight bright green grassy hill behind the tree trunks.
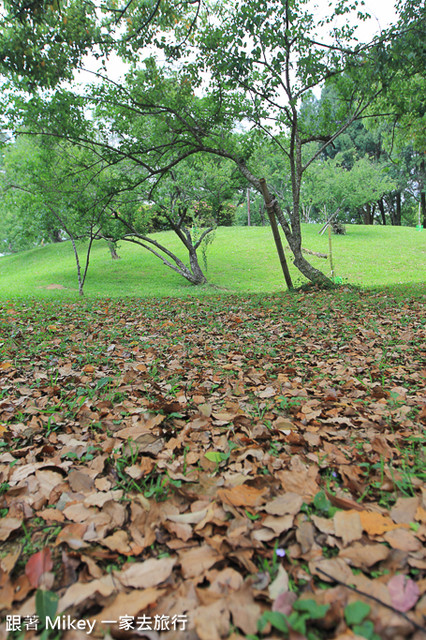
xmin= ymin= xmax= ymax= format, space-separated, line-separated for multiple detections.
xmin=0 ymin=225 xmax=426 ymax=299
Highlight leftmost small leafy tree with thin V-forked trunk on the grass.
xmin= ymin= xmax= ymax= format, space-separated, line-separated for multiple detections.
xmin=2 ymin=136 xmax=111 ymax=296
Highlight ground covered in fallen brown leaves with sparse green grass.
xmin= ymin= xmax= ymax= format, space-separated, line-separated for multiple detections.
xmin=0 ymin=292 xmax=426 ymax=640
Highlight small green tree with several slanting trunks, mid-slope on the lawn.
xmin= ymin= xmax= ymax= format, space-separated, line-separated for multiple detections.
xmin=98 ymin=152 xmax=243 ymax=285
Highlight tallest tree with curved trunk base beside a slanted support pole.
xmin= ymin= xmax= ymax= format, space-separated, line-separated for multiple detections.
xmin=190 ymin=0 xmax=416 ymax=284
